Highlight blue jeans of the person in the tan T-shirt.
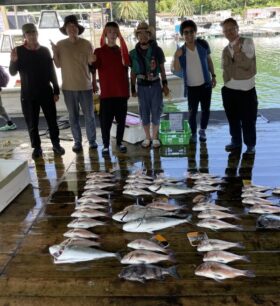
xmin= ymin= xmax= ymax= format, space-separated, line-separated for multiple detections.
xmin=63 ymin=90 xmax=96 ymax=145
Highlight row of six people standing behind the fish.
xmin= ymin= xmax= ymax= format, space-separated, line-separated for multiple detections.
xmin=3 ymin=15 xmax=257 ymax=158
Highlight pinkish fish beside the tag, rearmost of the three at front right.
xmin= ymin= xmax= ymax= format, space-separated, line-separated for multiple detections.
xmin=197 ymin=239 xmax=244 ymax=252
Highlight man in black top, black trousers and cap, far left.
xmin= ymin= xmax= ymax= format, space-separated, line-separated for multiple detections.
xmin=9 ymin=23 xmax=65 ymax=158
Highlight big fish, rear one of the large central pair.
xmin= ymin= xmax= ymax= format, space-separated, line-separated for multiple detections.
xmin=112 ymin=205 xmax=178 ymax=222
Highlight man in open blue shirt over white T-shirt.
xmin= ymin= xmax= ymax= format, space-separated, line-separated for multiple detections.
xmin=173 ymin=20 xmax=216 ymax=142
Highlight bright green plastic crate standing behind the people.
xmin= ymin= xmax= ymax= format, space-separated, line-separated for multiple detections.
xmin=159 ymin=120 xmax=191 ymax=146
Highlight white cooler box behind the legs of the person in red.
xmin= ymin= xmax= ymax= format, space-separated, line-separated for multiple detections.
xmin=111 ymin=113 xmax=146 ymax=144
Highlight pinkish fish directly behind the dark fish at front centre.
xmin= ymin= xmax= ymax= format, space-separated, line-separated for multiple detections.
xmin=121 ymin=250 xmax=175 ymax=265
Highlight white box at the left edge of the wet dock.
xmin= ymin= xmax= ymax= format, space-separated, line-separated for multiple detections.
xmin=0 ymin=159 xmax=30 ymax=212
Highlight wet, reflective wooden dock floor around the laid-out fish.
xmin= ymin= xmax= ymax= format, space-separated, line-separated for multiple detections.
xmin=0 ymin=120 xmax=280 ymax=306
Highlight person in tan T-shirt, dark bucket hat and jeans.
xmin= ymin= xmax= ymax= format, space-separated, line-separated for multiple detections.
xmin=52 ymin=15 xmax=98 ymax=153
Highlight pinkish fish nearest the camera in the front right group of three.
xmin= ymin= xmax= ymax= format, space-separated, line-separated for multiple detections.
xmin=195 ymin=261 xmax=255 ymax=281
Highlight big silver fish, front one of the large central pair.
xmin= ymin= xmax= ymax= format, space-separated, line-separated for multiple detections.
xmin=123 ymin=217 xmax=190 ymax=233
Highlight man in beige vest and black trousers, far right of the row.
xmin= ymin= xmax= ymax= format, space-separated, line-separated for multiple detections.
xmin=221 ymin=18 xmax=258 ymax=154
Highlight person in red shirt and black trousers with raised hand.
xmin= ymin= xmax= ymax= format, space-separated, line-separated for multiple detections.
xmin=93 ymin=21 xmax=130 ymax=156
